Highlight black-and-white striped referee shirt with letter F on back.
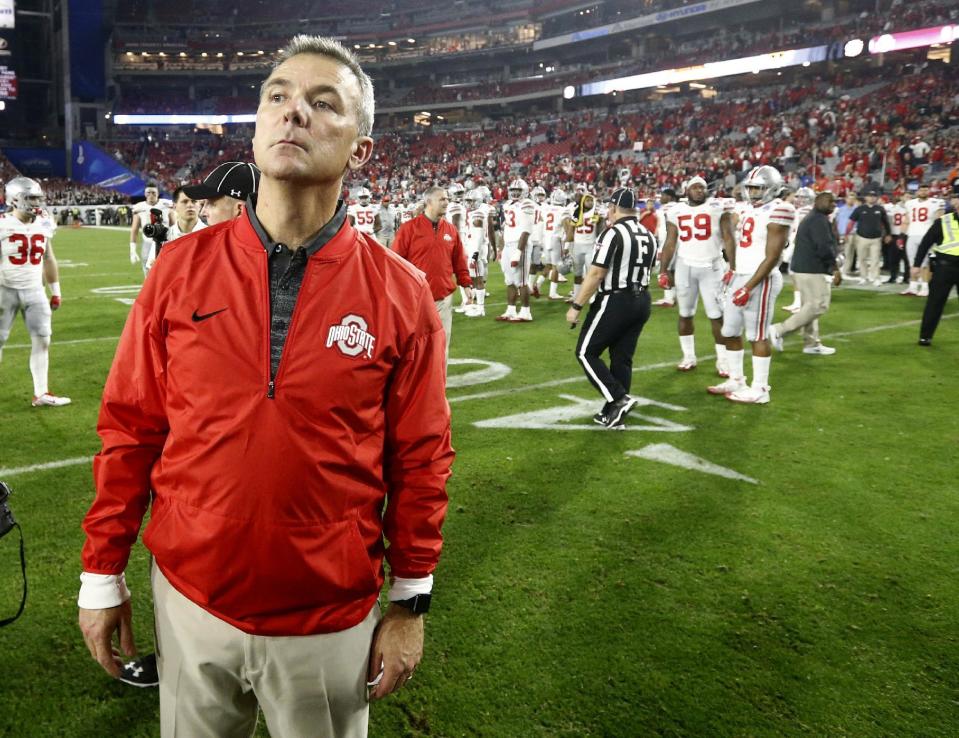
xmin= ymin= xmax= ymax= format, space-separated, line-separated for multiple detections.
xmin=592 ymin=215 xmax=656 ymax=295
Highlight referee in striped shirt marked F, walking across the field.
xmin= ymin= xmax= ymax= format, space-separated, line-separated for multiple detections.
xmin=566 ymin=188 xmax=656 ymax=430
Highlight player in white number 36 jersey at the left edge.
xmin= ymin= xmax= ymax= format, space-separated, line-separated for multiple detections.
xmin=0 ymin=177 xmax=70 ymax=407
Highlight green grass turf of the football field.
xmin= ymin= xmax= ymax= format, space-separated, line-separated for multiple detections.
xmin=0 ymin=229 xmax=959 ymax=738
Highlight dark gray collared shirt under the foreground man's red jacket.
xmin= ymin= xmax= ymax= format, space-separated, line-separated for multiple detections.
xmin=246 ymin=195 xmax=346 ymax=382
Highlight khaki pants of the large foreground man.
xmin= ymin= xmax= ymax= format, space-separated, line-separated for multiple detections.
xmin=151 ymin=564 xmax=379 ymax=738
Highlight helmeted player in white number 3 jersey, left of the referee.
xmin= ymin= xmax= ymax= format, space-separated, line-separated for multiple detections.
xmin=496 ymin=179 xmax=536 ymax=323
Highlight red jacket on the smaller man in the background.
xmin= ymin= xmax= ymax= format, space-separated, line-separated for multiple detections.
xmin=393 ymin=214 xmax=473 ymax=300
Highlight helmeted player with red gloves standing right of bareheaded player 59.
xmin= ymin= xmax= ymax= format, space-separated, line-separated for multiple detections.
xmin=707 ymin=165 xmax=796 ymax=404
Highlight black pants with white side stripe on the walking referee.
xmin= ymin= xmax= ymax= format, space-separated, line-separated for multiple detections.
xmin=576 ymin=290 xmax=650 ymax=402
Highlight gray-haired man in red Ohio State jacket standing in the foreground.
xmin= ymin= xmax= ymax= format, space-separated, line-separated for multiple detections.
xmin=80 ymin=36 xmax=453 ymax=738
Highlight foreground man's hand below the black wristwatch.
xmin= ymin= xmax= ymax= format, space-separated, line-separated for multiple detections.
xmin=367 ymin=604 xmax=423 ymax=700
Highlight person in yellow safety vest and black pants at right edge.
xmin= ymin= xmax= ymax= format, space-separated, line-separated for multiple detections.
xmin=912 ymin=193 xmax=959 ymax=346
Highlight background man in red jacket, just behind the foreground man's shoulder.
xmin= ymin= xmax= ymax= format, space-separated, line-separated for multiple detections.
xmin=393 ymin=187 xmax=473 ymax=357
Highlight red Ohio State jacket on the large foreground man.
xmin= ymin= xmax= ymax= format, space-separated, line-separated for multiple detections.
xmin=83 ymin=215 xmax=453 ymax=635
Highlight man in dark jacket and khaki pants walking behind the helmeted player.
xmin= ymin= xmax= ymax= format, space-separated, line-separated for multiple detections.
xmin=769 ymin=191 xmax=842 ymax=356
